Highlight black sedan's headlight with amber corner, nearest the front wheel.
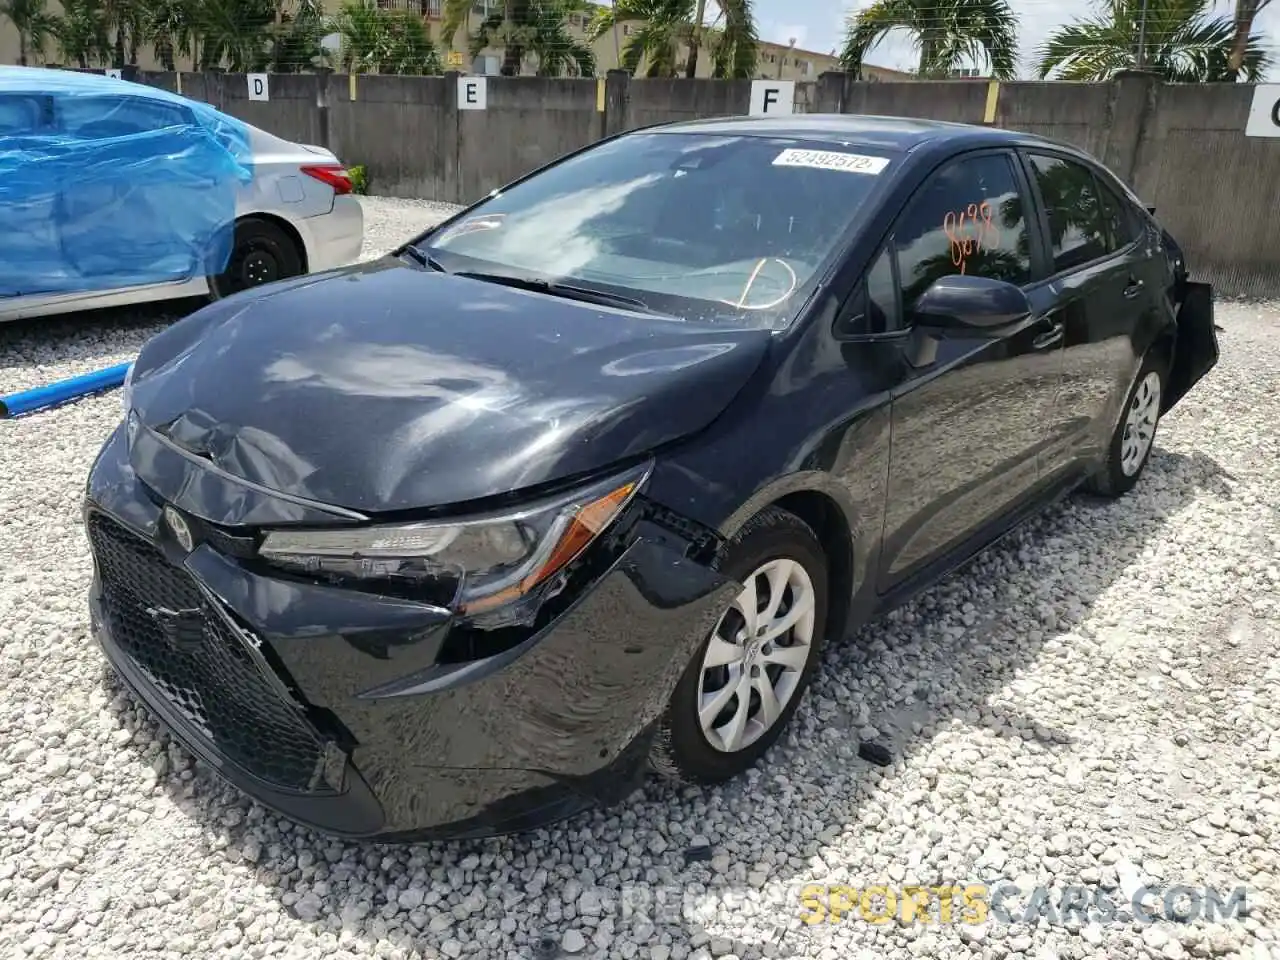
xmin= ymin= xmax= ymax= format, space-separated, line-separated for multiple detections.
xmin=259 ymin=465 xmax=649 ymax=613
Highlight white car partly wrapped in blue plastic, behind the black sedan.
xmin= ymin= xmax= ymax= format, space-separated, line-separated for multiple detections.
xmin=0 ymin=67 xmax=364 ymax=320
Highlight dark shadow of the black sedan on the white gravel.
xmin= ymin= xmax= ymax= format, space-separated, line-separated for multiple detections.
xmin=94 ymin=448 xmax=1233 ymax=960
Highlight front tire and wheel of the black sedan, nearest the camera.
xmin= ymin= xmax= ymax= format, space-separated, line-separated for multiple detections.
xmin=649 ymin=507 xmax=829 ymax=785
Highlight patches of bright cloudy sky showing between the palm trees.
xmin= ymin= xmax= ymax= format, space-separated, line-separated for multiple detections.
xmin=755 ymin=0 xmax=1280 ymax=79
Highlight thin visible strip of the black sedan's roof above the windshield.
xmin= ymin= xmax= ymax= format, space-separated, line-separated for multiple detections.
xmin=635 ymin=114 xmax=1078 ymax=152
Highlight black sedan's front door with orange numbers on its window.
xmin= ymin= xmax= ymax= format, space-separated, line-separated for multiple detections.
xmin=878 ymin=151 xmax=1062 ymax=593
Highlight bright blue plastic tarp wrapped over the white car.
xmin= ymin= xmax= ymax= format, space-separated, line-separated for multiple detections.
xmin=0 ymin=67 xmax=253 ymax=297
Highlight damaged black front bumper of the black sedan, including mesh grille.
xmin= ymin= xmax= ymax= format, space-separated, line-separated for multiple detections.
xmin=86 ymin=429 xmax=737 ymax=840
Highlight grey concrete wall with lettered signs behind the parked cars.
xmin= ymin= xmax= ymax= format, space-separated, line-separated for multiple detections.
xmin=92 ymin=72 xmax=1280 ymax=296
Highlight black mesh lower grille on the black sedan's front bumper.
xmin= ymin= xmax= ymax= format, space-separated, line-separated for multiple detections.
xmin=88 ymin=513 xmax=328 ymax=792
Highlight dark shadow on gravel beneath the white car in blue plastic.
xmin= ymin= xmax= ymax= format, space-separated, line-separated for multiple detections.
xmin=0 ymin=298 xmax=207 ymax=376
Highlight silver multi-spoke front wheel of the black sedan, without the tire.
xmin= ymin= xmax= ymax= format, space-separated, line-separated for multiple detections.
xmin=698 ymin=559 xmax=815 ymax=753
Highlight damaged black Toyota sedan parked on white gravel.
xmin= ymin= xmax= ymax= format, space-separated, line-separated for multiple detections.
xmin=86 ymin=116 xmax=1217 ymax=840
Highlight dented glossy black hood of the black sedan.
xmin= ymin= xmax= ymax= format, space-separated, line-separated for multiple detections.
xmin=132 ymin=259 xmax=771 ymax=513
